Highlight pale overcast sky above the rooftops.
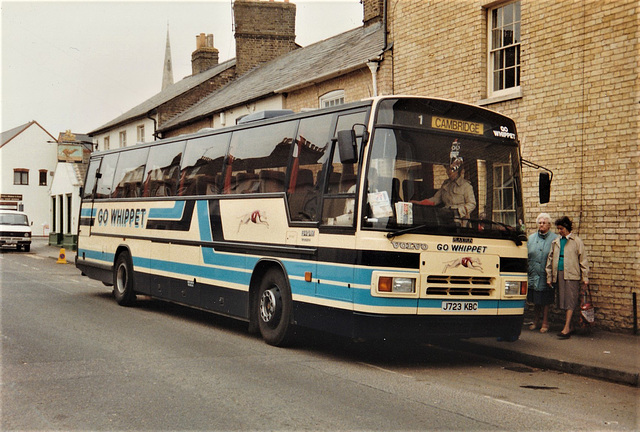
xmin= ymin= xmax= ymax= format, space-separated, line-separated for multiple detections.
xmin=0 ymin=0 xmax=362 ymax=138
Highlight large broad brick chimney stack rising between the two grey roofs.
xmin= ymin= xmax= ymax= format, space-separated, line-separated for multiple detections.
xmin=233 ymin=0 xmax=297 ymax=75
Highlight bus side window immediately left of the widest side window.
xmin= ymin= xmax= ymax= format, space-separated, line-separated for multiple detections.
xmin=178 ymin=133 xmax=231 ymax=196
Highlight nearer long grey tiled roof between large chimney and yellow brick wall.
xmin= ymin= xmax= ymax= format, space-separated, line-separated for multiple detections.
xmin=159 ymin=24 xmax=384 ymax=131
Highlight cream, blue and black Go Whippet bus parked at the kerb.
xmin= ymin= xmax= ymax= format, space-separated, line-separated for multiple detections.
xmin=76 ymin=96 xmax=527 ymax=345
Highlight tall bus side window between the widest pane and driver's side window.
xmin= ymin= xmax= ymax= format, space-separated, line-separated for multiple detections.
xmin=287 ymin=114 xmax=333 ymax=221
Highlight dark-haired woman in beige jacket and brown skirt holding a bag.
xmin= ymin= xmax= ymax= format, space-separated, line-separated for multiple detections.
xmin=546 ymin=216 xmax=589 ymax=339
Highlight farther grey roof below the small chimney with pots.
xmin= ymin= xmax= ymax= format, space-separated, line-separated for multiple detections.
xmin=89 ymin=59 xmax=236 ymax=135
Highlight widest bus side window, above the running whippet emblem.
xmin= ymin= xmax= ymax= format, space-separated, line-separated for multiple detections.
xmin=224 ymin=120 xmax=298 ymax=194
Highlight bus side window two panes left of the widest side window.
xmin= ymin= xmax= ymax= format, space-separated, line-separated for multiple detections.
xmin=142 ymin=141 xmax=185 ymax=197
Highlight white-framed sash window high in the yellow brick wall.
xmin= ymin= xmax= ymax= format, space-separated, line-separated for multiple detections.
xmin=488 ymin=0 xmax=521 ymax=97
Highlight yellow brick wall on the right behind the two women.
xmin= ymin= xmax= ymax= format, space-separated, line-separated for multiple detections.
xmin=387 ymin=0 xmax=640 ymax=330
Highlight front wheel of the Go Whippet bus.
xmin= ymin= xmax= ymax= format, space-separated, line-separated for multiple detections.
xmin=257 ymin=269 xmax=293 ymax=346
